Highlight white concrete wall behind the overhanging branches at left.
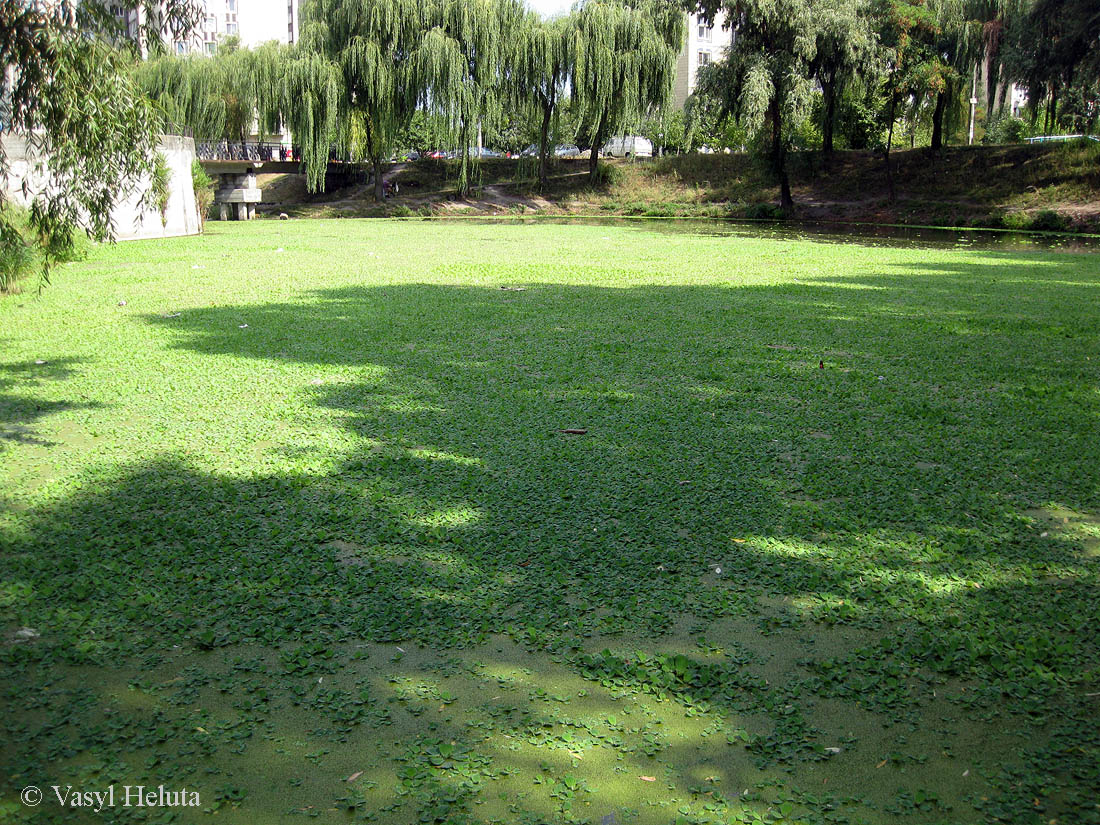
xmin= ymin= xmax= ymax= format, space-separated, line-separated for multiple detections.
xmin=0 ymin=135 xmax=202 ymax=241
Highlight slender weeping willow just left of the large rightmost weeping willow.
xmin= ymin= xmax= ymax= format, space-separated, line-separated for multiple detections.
xmin=507 ymin=12 xmax=573 ymax=191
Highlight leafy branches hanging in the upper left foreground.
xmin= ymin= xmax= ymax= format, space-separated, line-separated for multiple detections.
xmin=0 ymin=0 xmax=199 ymax=281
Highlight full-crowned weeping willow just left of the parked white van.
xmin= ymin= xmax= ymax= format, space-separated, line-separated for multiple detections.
xmin=572 ymin=0 xmax=684 ymax=180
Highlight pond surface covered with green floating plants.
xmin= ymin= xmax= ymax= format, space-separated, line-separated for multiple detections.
xmin=0 ymin=220 xmax=1100 ymax=825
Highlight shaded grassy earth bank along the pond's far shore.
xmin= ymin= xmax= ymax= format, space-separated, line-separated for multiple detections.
xmin=255 ymin=143 xmax=1100 ymax=232
